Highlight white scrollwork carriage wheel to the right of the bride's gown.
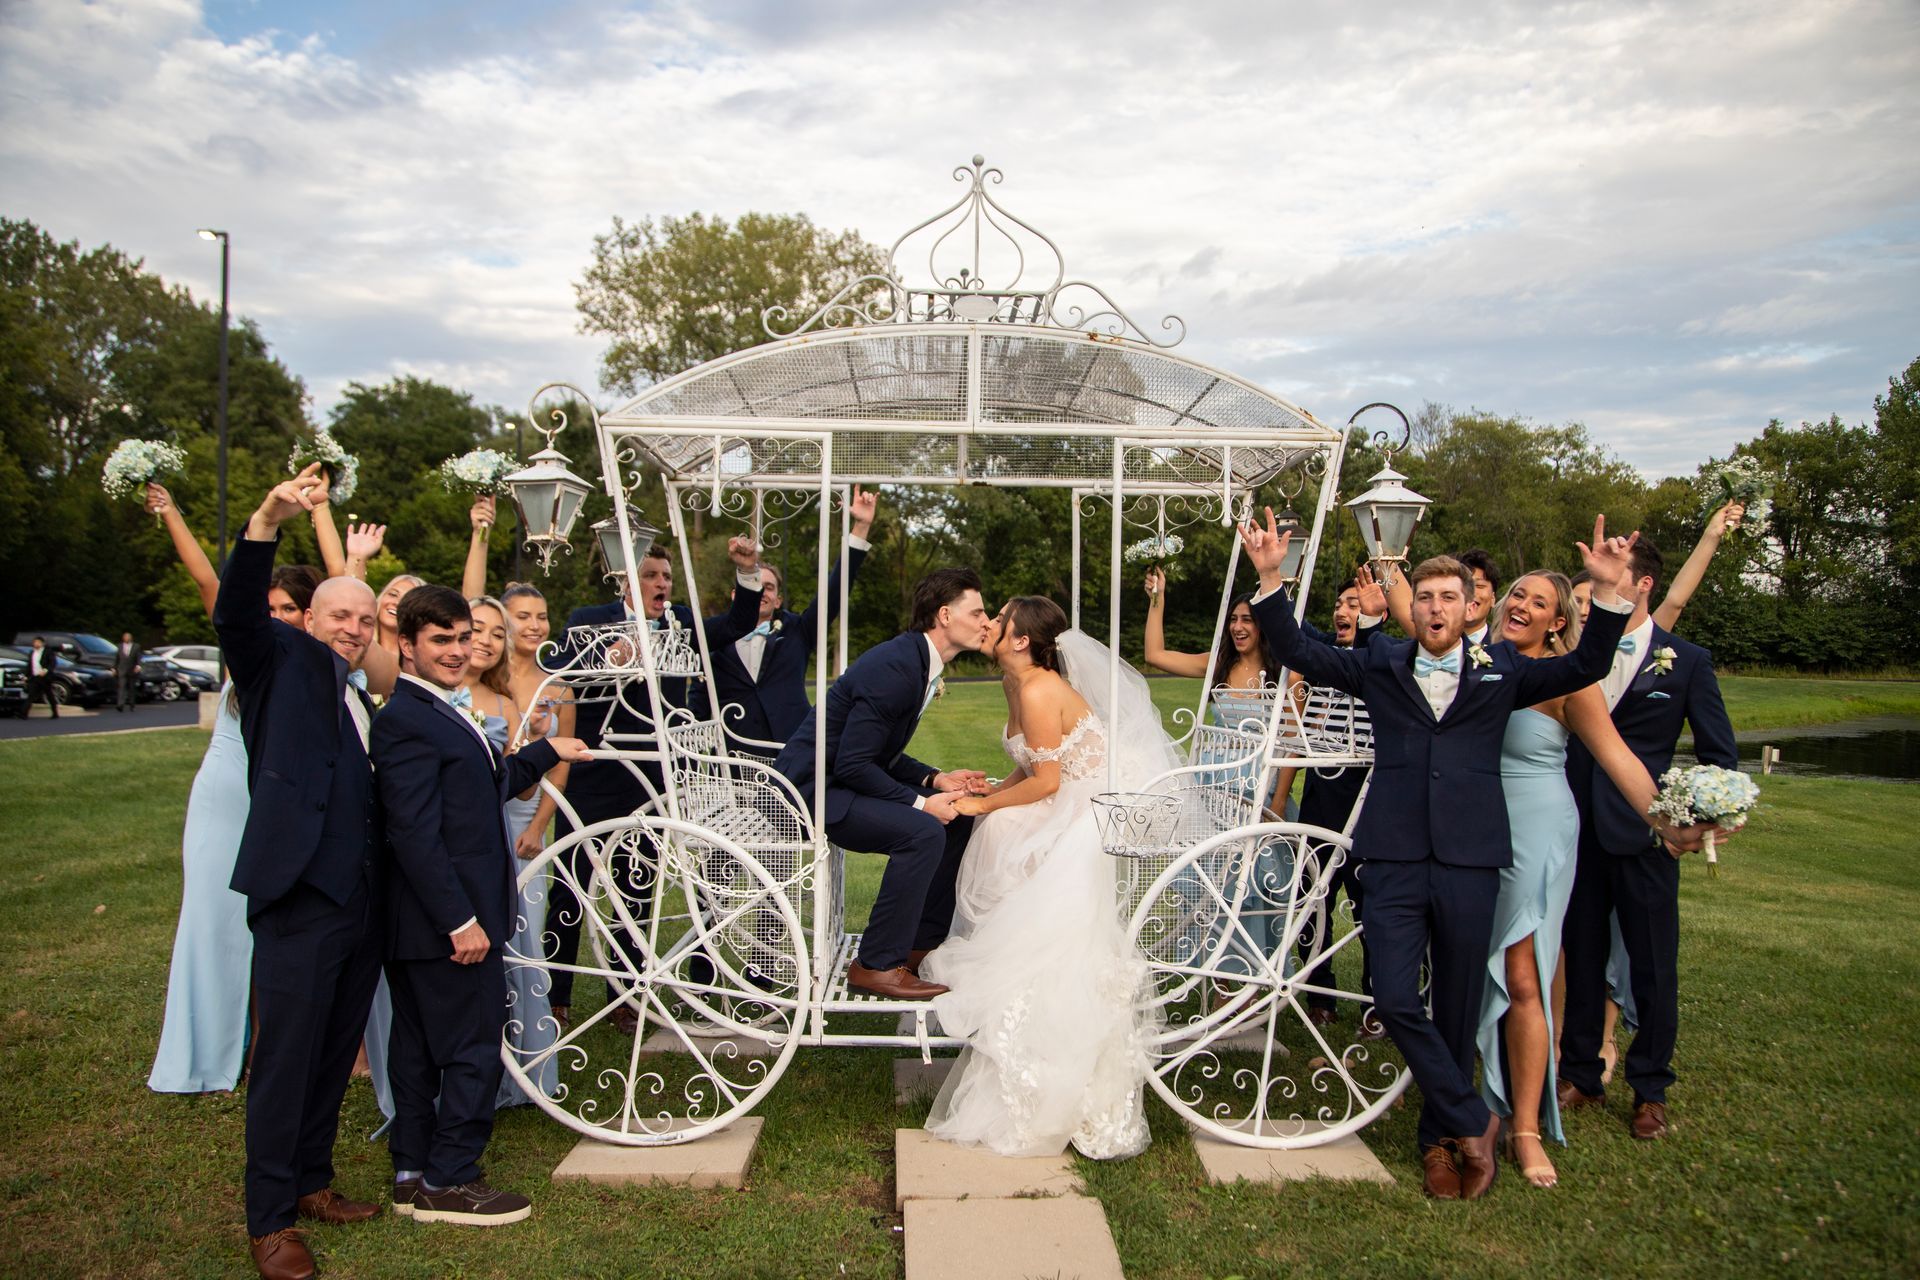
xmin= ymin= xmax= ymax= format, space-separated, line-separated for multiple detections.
xmin=1131 ymin=823 xmax=1409 ymax=1148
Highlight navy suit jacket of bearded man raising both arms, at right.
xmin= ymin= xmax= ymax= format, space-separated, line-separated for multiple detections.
xmin=1254 ymin=591 xmax=1626 ymax=867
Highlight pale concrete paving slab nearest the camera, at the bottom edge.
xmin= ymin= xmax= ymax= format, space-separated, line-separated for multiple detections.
xmin=906 ymin=1196 xmax=1125 ymax=1280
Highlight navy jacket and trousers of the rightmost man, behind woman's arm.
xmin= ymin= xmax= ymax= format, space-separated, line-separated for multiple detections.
xmin=1559 ymin=626 xmax=1740 ymax=1102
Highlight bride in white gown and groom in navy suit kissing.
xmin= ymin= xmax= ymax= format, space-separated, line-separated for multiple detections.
xmin=774 ymin=568 xmax=1179 ymax=1157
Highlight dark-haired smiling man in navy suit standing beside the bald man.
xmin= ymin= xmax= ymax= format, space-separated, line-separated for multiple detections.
xmin=372 ymin=585 xmax=588 ymax=1226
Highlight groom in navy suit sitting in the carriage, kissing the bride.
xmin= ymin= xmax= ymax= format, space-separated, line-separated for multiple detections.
xmin=774 ymin=568 xmax=993 ymax=1000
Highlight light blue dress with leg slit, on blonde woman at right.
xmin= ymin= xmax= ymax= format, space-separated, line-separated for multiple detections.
xmin=1478 ymin=708 xmax=1580 ymax=1142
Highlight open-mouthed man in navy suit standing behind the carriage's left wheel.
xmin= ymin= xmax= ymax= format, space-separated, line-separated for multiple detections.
xmin=547 ymin=543 xmax=707 ymax=1032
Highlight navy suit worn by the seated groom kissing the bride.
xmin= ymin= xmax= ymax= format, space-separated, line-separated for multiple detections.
xmin=774 ymin=631 xmax=973 ymax=969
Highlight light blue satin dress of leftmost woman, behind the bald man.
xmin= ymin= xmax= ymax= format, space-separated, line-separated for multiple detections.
xmin=146 ymin=685 xmax=253 ymax=1094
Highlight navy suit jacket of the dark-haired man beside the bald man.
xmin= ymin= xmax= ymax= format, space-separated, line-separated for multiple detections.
xmin=372 ymin=679 xmax=561 ymax=960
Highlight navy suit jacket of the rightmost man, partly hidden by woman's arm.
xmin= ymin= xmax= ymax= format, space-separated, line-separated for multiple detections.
xmin=1567 ymin=624 xmax=1740 ymax=854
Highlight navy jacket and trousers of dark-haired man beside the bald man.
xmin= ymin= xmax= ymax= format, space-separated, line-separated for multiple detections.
xmin=372 ymin=679 xmax=559 ymax=1186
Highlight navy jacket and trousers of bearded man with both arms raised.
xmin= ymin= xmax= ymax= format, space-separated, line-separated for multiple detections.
xmin=1254 ymin=591 xmax=1626 ymax=1148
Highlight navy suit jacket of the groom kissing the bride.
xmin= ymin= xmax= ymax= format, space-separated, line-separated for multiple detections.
xmin=774 ymin=631 xmax=935 ymax=823
